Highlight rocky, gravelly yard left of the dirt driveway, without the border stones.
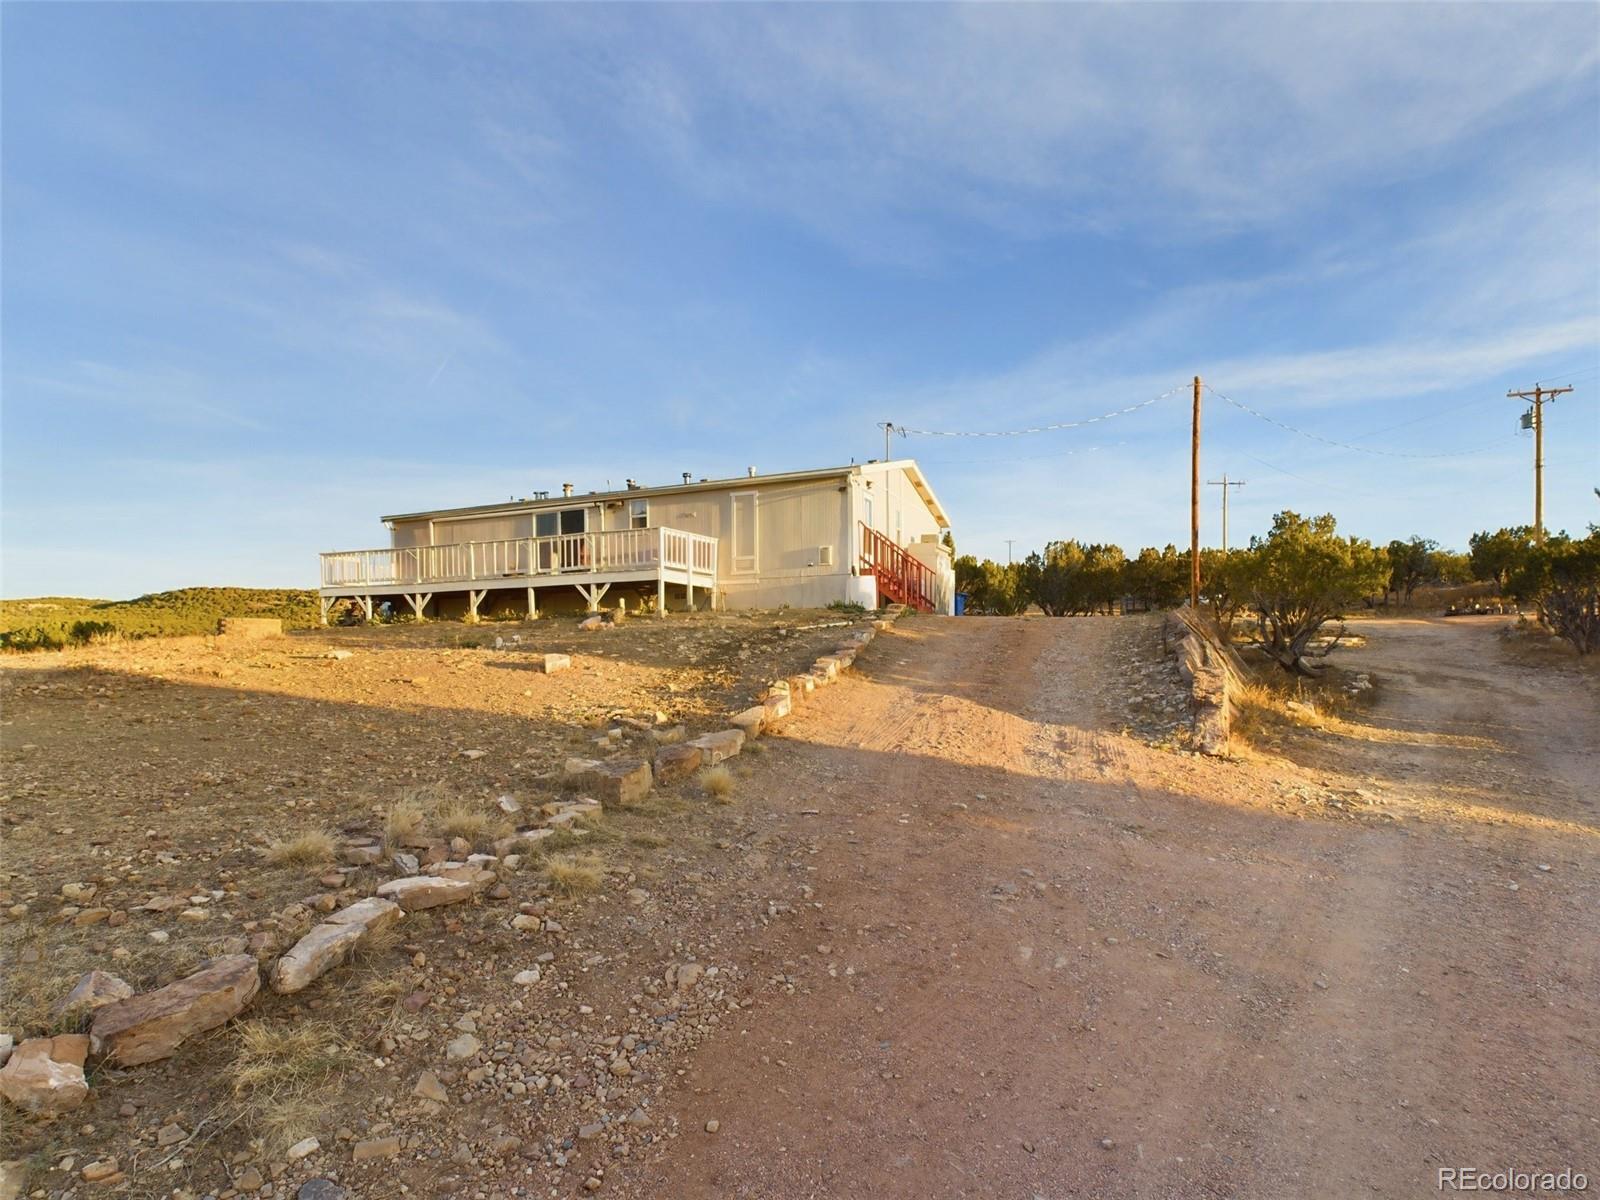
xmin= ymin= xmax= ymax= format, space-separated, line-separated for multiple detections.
xmin=0 ymin=613 xmax=889 ymax=1197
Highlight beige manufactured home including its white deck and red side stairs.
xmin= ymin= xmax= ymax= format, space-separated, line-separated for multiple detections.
xmin=322 ymin=459 xmax=955 ymax=621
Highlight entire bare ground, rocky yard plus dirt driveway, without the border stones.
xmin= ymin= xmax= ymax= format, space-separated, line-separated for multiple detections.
xmin=0 ymin=614 xmax=1600 ymax=1200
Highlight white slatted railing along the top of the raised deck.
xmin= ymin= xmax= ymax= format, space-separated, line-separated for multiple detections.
xmin=322 ymin=525 xmax=717 ymax=587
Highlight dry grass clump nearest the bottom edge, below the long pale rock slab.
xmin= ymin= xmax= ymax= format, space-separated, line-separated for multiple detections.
xmin=227 ymin=1021 xmax=350 ymax=1155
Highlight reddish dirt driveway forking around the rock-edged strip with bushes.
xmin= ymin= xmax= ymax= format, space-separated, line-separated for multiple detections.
xmin=606 ymin=619 xmax=1600 ymax=1200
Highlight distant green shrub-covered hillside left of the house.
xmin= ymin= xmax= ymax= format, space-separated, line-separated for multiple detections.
xmin=0 ymin=587 xmax=317 ymax=650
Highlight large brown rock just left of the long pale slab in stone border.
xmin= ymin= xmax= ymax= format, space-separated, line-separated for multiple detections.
xmin=90 ymin=954 xmax=261 ymax=1067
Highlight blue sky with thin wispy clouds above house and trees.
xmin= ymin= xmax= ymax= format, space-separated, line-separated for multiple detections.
xmin=0 ymin=5 xmax=1600 ymax=595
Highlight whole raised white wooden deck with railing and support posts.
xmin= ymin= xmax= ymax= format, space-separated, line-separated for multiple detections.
xmin=318 ymin=526 xmax=717 ymax=621
